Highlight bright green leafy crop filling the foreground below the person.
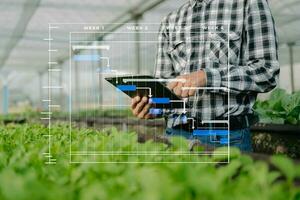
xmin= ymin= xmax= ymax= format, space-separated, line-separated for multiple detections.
xmin=0 ymin=125 xmax=300 ymax=200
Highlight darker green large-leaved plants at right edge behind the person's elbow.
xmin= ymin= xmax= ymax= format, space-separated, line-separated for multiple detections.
xmin=255 ymin=89 xmax=300 ymax=125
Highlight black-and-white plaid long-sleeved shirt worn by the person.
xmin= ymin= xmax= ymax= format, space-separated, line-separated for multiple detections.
xmin=155 ymin=0 xmax=280 ymax=127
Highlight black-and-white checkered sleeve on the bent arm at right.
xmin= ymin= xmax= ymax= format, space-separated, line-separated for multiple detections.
xmin=205 ymin=0 xmax=280 ymax=93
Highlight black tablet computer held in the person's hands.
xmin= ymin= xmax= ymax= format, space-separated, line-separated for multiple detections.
xmin=105 ymin=76 xmax=186 ymax=109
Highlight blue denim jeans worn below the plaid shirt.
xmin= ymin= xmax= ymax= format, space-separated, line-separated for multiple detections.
xmin=166 ymin=128 xmax=253 ymax=152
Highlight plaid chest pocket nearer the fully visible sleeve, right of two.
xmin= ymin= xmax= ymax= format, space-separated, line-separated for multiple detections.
xmin=206 ymin=32 xmax=241 ymax=64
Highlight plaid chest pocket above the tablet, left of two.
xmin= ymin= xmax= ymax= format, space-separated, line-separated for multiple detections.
xmin=168 ymin=41 xmax=187 ymax=73
